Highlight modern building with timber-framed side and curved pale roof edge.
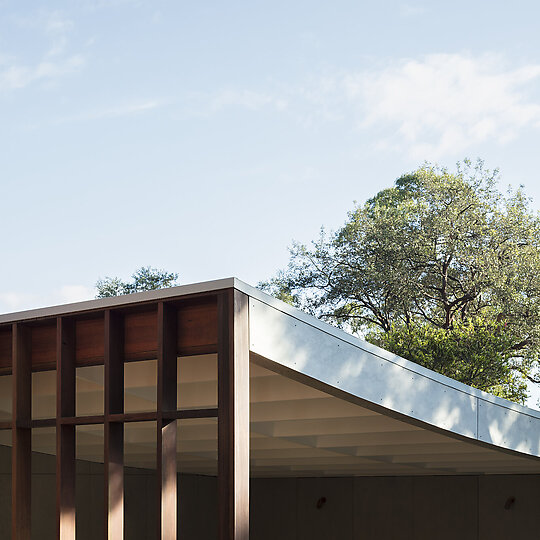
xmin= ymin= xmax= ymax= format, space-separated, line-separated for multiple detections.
xmin=0 ymin=278 xmax=540 ymax=540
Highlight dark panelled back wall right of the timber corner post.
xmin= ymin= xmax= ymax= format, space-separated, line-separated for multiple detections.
xmin=251 ymin=475 xmax=540 ymax=540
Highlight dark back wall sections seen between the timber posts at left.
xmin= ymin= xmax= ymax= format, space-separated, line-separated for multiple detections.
xmin=0 ymin=446 xmax=217 ymax=540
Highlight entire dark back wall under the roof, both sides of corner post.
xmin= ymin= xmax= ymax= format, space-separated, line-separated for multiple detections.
xmin=0 ymin=447 xmax=540 ymax=540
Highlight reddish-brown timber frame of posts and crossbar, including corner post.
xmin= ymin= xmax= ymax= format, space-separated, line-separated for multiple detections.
xmin=0 ymin=287 xmax=249 ymax=540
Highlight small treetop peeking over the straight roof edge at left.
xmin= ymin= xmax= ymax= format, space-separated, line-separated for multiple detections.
xmin=96 ymin=266 xmax=178 ymax=298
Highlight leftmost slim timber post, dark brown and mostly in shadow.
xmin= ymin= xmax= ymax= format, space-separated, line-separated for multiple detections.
xmin=11 ymin=323 xmax=32 ymax=540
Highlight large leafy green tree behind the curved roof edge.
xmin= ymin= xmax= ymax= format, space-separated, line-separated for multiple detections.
xmin=261 ymin=160 xmax=540 ymax=402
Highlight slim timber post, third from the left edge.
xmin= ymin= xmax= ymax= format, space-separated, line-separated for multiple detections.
xmin=104 ymin=310 xmax=124 ymax=540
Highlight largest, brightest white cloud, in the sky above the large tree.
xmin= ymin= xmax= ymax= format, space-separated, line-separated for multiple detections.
xmin=194 ymin=54 xmax=540 ymax=161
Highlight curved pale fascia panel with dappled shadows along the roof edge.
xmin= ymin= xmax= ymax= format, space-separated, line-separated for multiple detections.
xmin=244 ymin=287 xmax=540 ymax=457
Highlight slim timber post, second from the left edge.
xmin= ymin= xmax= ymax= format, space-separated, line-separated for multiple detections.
xmin=56 ymin=317 xmax=76 ymax=540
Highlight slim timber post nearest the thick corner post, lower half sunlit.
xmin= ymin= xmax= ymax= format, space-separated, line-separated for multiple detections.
xmin=157 ymin=302 xmax=178 ymax=540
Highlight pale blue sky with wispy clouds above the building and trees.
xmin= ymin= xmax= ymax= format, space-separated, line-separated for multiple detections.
xmin=0 ymin=0 xmax=540 ymax=404
